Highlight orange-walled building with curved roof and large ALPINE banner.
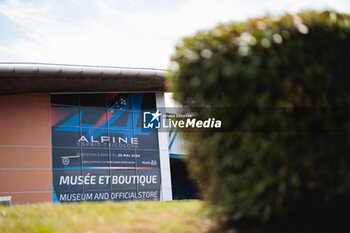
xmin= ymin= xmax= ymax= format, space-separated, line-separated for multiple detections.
xmin=0 ymin=63 xmax=194 ymax=204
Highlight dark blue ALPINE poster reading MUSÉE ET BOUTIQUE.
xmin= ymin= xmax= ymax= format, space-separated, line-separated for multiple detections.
xmin=51 ymin=93 xmax=161 ymax=202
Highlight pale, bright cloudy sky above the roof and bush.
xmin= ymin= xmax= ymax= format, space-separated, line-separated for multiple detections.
xmin=0 ymin=0 xmax=350 ymax=69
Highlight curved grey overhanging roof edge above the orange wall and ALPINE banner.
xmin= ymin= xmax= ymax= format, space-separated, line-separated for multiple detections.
xmin=0 ymin=62 xmax=167 ymax=95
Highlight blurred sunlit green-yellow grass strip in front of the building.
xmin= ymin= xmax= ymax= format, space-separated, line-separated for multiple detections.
xmin=0 ymin=200 xmax=213 ymax=233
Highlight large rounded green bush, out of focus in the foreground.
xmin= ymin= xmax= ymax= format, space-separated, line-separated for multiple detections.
xmin=169 ymin=11 xmax=350 ymax=232
